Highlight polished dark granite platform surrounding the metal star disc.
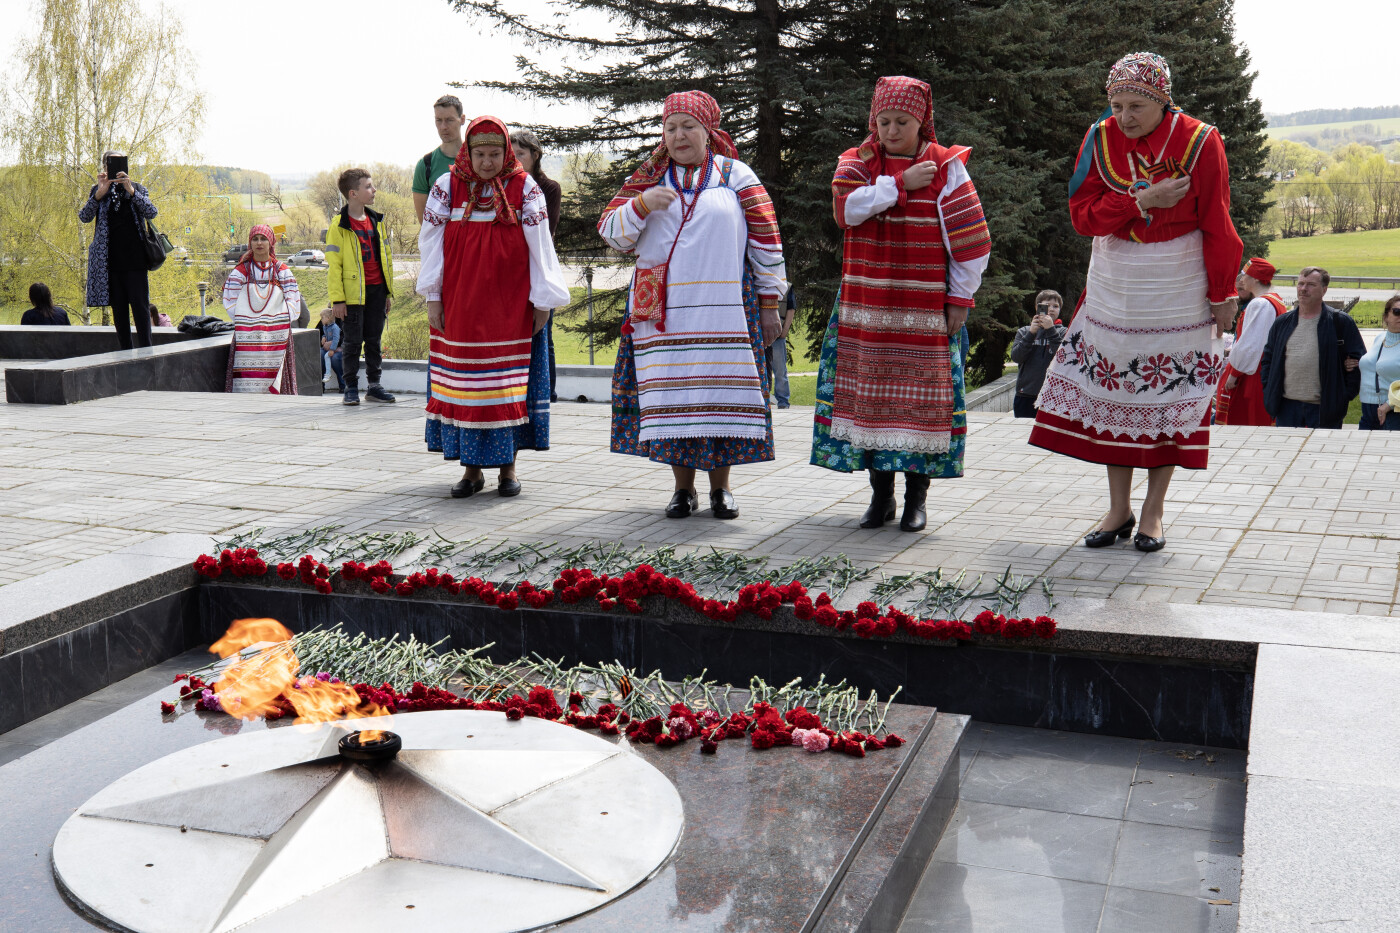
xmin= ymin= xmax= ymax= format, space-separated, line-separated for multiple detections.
xmin=0 ymin=675 xmax=966 ymax=933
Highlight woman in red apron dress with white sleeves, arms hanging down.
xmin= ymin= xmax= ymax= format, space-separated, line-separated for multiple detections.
xmin=417 ymin=116 xmax=568 ymax=499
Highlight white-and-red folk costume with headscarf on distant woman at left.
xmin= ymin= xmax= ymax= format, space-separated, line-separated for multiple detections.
xmin=224 ymin=224 xmax=301 ymax=395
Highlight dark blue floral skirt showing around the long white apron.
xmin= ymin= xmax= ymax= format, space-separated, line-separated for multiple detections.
xmin=612 ymin=265 xmax=773 ymax=471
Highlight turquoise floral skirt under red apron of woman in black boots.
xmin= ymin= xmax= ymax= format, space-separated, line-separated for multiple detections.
xmin=812 ymin=301 xmax=967 ymax=479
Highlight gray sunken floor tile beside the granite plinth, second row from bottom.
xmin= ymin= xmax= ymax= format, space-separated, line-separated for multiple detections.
xmin=934 ymin=800 xmax=1119 ymax=884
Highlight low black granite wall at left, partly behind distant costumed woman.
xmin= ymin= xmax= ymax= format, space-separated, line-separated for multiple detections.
xmin=4 ymin=328 xmax=322 ymax=405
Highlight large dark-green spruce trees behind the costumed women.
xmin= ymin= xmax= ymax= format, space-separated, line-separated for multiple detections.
xmin=452 ymin=0 xmax=1270 ymax=378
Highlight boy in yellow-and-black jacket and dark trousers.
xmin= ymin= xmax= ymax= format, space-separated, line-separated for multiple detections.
xmin=326 ymin=168 xmax=393 ymax=405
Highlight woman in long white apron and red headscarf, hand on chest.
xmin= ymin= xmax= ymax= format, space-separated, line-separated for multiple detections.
xmin=598 ymin=91 xmax=788 ymax=518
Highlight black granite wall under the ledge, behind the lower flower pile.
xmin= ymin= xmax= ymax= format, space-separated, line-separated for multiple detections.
xmin=200 ymin=583 xmax=1253 ymax=748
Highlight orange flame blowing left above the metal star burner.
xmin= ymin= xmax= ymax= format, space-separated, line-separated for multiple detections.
xmin=209 ymin=619 xmax=393 ymax=722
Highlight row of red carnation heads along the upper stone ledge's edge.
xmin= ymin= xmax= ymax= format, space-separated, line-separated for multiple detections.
xmin=195 ymin=548 xmax=1056 ymax=642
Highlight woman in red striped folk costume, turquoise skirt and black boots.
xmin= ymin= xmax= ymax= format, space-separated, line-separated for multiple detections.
xmin=812 ymin=77 xmax=991 ymax=531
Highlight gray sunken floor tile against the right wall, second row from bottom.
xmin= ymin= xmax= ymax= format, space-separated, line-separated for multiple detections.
xmin=1109 ymin=822 xmax=1243 ymax=901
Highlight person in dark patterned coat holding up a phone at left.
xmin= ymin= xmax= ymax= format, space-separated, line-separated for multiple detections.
xmin=78 ymin=150 xmax=157 ymax=350
